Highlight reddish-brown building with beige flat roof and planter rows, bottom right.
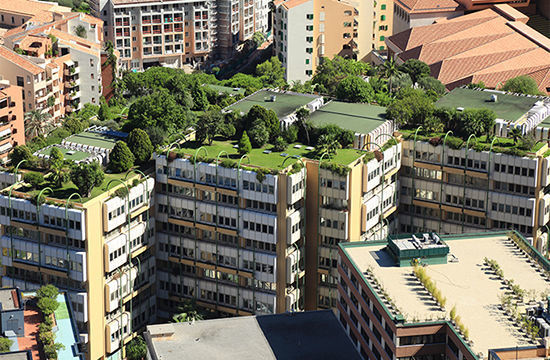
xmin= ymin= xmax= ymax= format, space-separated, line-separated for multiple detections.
xmin=337 ymin=231 xmax=550 ymax=360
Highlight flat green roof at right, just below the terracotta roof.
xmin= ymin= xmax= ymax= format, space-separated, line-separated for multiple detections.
xmin=436 ymin=88 xmax=538 ymax=121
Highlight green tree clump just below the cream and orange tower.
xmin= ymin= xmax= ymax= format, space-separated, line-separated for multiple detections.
xmin=312 ymin=56 xmax=371 ymax=95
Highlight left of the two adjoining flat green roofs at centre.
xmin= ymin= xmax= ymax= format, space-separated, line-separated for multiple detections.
xmin=227 ymin=90 xmax=315 ymax=118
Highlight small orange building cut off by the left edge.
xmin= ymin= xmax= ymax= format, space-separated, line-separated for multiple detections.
xmin=0 ymin=81 xmax=25 ymax=163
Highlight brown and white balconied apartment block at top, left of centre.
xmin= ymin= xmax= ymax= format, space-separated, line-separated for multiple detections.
xmin=91 ymin=0 xmax=269 ymax=70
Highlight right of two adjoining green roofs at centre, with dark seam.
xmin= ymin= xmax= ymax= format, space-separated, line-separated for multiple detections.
xmin=310 ymin=101 xmax=386 ymax=134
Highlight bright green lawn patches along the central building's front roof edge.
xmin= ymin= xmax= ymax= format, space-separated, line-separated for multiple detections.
xmin=175 ymin=140 xmax=365 ymax=170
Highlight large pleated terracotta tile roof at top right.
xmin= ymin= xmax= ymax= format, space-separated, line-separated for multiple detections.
xmin=387 ymin=5 xmax=550 ymax=92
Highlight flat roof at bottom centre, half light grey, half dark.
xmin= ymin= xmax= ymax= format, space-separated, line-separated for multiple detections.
xmin=147 ymin=310 xmax=360 ymax=360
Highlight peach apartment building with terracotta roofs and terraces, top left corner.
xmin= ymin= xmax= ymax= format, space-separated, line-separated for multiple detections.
xmin=0 ymin=5 xmax=110 ymax=123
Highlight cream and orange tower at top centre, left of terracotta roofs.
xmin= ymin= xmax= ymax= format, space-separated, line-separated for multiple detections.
xmin=273 ymin=0 xmax=393 ymax=82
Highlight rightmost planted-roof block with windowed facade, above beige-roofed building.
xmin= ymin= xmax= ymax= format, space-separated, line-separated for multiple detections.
xmin=399 ymin=88 xmax=550 ymax=252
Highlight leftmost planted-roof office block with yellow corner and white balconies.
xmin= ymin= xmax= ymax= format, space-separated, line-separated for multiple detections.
xmin=0 ymin=129 xmax=156 ymax=359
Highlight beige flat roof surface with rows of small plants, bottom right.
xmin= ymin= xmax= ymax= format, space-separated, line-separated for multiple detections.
xmin=341 ymin=233 xmax=550 ymax=357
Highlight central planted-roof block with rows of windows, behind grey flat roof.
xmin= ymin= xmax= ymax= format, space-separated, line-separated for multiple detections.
xmin=155 ymin=148 xmax=306 ymax=318
